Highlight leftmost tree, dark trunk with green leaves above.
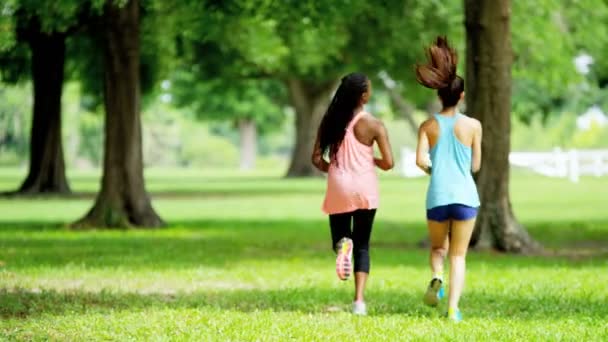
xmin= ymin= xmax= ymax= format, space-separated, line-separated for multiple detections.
xmin=0 ymin=0 xmax=100 ymax=193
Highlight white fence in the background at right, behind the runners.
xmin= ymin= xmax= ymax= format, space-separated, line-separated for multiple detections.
xmin=401 ymin=148 xmax=608 ymax=182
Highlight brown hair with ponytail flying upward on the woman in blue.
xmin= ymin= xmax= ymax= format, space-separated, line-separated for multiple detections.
xmin=416 ymin=36 xmax=464 ymax=107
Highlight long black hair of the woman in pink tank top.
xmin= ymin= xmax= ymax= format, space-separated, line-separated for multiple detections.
xmin=319 ymin=73 xmax=369 ymax=161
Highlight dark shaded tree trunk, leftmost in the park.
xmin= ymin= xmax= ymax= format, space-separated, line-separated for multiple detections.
xmin=17 ymin=32 xmax=70 ymax=194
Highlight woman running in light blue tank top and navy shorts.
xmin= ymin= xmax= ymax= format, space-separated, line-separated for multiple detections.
xmin=416 ymin=37 xmax=481 ymax=322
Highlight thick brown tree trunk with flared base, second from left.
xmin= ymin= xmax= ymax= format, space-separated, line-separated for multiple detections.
xmin=75 ymin=0 xmax=163 ymax=228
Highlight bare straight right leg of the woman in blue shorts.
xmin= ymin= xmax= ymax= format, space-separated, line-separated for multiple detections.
xmin=448 ymin=217 xmax=475 ymax=311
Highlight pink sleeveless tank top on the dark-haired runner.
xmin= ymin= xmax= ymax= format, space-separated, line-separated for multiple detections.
xmin=323 ymin=112 xmax=379 ymax=214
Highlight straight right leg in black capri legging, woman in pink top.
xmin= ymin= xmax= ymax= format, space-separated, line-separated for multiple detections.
xmin=353 ymin=209 xmax=376 ymax=302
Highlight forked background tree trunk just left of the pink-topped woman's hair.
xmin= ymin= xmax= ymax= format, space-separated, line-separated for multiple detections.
xmin=287 ymin=79 xmax=336 ymax=177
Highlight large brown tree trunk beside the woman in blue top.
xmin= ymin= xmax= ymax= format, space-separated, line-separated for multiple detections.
xmin=465 ymin=0 xmax=538 ymax=253
